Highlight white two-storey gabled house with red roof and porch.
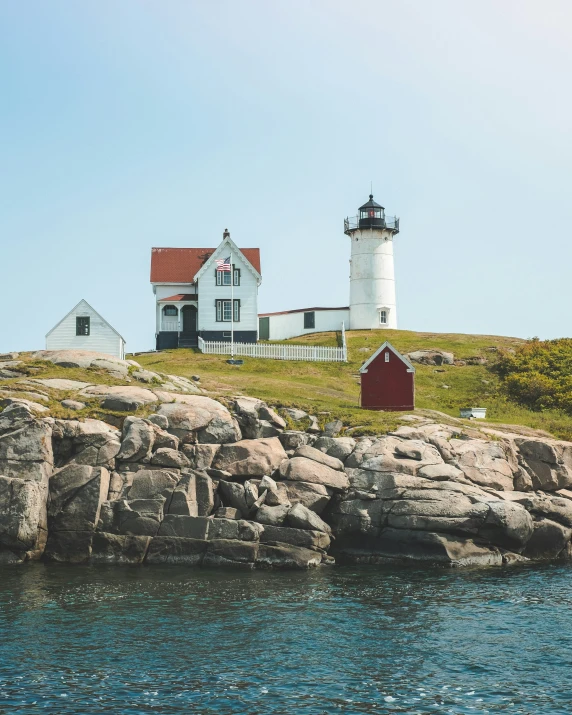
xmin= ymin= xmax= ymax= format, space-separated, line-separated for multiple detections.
xmin=151 ymin=230 xmax=262 ymax=350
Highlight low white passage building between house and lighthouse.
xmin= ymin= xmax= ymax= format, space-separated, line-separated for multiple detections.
xmin=258 ymin=308 xmax=350 ymax=340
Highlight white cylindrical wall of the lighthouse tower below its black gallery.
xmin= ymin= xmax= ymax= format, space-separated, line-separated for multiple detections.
xmin=349 ymin=228 xmax=397 ymax=330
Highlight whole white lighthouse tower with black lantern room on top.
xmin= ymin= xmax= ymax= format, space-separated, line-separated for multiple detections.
xmin=344 ymin=194 xmax=399 ymax=330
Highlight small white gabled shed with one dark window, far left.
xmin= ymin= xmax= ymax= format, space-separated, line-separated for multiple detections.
xmin=46 ymin=300 xmax=125 ymax=360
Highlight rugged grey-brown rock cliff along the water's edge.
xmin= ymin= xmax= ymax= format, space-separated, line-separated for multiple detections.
xmin=5 ymin=393 xmax=572 ymax=568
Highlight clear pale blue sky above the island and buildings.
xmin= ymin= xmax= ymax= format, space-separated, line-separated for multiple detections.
xmin=0 ymin=0 xmax=572 ymax=352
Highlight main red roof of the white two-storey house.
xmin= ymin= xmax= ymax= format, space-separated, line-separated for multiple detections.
xmin=151 ymin=248 xmax=260 ymax=283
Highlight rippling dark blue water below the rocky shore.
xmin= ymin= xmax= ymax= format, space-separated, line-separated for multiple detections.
xmin=0 ymin=564 xmax=572 ymax=715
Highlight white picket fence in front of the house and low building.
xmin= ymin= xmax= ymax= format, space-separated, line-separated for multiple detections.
xmin=199 ymin=325 xmax=348 ymax=362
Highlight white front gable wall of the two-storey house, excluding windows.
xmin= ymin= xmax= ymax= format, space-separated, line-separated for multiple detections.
xmin=197 ymin=252 xmax=258 ymax=332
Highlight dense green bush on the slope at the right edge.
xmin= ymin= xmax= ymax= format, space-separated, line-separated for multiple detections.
xmin=493 ymin=338 xmax=572 ymax=414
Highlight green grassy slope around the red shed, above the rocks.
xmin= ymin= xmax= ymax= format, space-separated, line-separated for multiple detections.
xmin=137 ymin=330 xmax=572 ymax=440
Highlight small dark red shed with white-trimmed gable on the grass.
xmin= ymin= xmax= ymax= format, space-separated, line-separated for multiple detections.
xmin=359 ymin=342 xmax=415 ymax=411
